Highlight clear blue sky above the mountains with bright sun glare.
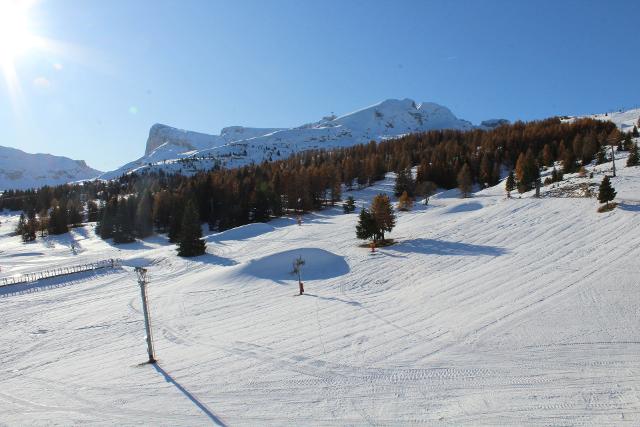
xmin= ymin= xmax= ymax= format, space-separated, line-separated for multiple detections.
xmin=0 ymin=0 xmax=640 ymax=170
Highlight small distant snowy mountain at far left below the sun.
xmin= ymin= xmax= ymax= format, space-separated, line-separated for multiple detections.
xmin=0 ymin=146 xmax=102 ymax=190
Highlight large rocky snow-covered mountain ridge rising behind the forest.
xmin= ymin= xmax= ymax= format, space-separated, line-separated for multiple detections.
xmin=102 ymin=99 xmax=480 ymax=179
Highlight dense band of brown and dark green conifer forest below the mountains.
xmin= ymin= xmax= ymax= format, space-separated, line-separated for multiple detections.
xmin=0 ymin=118 xmax=622 ymax=246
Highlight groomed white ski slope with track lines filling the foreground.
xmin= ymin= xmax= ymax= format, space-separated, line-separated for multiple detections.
xmin=0 ymin=150 xmax=640 ymax=426
